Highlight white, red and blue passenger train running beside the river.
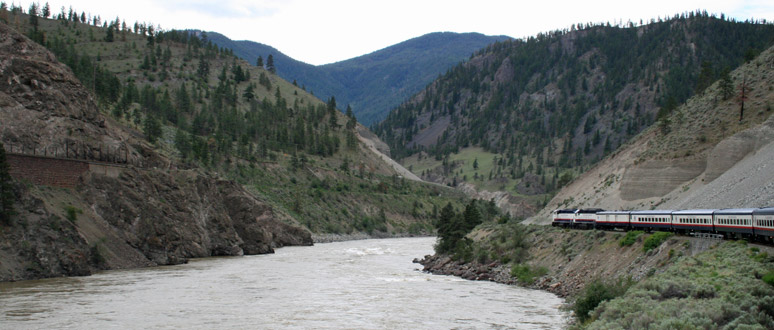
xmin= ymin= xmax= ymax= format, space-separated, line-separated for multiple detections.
xmin=551 ymin=207 xmax=774 ymax=243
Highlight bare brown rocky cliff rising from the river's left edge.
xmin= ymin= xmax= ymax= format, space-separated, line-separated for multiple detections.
xmin=0 ymin=24 xmax=312 ymax=281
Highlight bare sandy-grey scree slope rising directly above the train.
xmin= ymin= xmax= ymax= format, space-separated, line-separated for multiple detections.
xmin=530 ymin=42 xmax=774 ymax=223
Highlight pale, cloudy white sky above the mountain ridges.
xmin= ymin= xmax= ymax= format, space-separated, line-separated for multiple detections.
xmin=10 ymin=0 xmax=774 ymax=65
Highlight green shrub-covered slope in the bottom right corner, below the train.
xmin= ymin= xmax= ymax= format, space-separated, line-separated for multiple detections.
xmin=588 ymin=242 xmax=774 ymax=329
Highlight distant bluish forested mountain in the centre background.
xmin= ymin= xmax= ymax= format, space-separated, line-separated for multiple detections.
xmin=207 ymin=32 xmax=510 ymax=126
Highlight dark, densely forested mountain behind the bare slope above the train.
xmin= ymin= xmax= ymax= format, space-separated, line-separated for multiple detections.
xmin=374 ymin=12 xmax=774 ymax=216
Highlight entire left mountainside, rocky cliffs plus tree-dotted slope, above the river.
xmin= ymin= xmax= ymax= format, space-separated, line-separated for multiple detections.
xmin=0 ymin=7 xmax=465 ymax=281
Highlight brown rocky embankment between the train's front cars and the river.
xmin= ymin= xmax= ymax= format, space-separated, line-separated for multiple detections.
xmin=421 ymin=225 xmax=708 ymax=297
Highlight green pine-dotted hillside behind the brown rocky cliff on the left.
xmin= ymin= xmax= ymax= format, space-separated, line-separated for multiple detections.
xmin=0 ymin=5 xmax=462 ymax=235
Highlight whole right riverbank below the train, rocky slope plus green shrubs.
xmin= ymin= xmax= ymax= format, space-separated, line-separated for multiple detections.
xmin=422 ymin=209 xmax=774 ymax=329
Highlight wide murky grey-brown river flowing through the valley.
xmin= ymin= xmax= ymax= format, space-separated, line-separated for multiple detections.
xmin=0 ymin=238 xmax=567 ymax=329
